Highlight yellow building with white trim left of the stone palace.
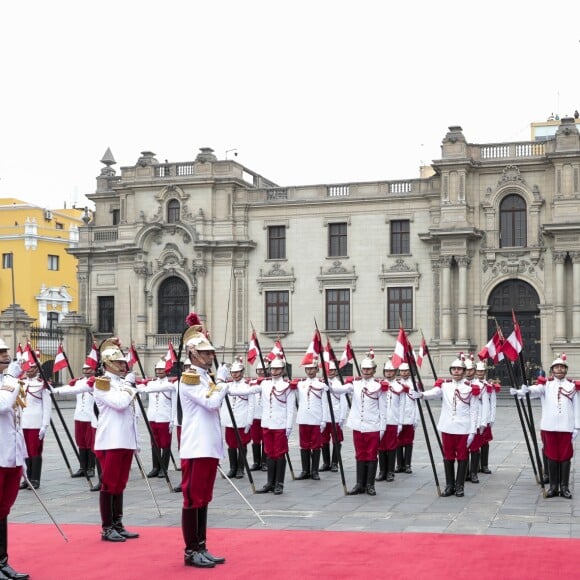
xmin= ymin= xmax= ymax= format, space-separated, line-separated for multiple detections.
xmin=0 ymin=198 xmax=84 ymax=328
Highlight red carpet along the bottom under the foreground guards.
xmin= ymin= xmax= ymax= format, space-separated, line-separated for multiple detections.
xmin=9 ymin=523 xmax=580 ymax=580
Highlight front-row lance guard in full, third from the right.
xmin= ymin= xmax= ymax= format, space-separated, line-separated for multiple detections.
xmin=331 ymin=352 xmax=386 ymax=495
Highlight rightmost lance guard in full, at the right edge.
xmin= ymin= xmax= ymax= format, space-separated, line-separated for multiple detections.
xmin=518 ymin=354 xmax=580 ymax=499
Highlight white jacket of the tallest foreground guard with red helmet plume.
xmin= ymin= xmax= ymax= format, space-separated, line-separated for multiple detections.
xmin=179 ymin=366 xmax=228 ymax=459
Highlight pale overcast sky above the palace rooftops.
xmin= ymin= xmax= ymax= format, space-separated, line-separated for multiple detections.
xmin=0 ymin=0 xmax=580 ymax=208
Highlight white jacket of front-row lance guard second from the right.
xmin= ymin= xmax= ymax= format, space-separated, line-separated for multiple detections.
xmin=423 ymin=379 xmax=479 ymax=435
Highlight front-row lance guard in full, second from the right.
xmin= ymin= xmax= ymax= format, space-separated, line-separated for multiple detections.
xmin=411 ymin=358 xmax=480 ymax=497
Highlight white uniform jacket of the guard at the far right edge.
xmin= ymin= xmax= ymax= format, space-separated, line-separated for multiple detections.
xmin=530 ymin=377 xmax=580 ymax=433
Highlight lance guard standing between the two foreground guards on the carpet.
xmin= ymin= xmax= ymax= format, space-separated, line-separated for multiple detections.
xmin=137 ymin=358 xmax=177 ymax=477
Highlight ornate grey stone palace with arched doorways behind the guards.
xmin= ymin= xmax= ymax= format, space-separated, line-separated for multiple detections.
xmin=70 ymin=118 xmax=580 ymax=375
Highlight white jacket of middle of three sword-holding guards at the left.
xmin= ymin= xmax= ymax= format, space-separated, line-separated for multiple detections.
xmin=94 ymin=371 xmax=139 ymax=451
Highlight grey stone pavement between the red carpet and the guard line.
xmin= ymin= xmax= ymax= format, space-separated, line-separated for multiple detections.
xmin=9 ymin=399 xmax=580 ymax=538
